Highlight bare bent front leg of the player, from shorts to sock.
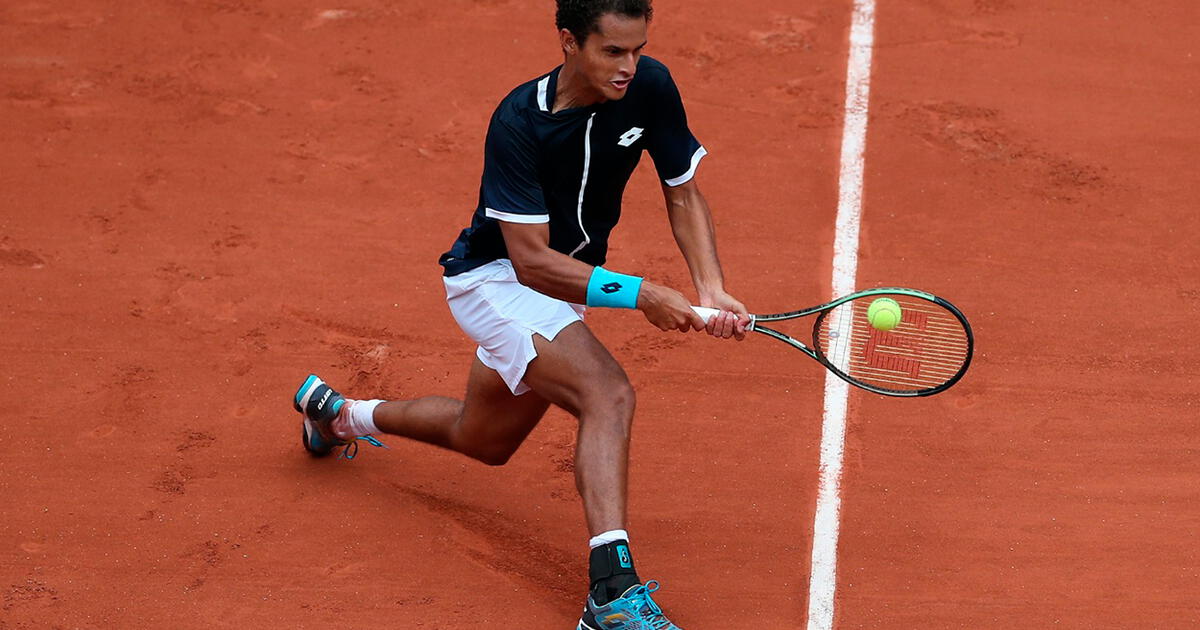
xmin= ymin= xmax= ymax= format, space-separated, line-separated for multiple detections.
xmin=524 ymin=322 xmax=635 ymax=535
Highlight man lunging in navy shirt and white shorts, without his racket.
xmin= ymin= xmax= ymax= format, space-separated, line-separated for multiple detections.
xmin=294 ymin=0 xmax=749 ymax=630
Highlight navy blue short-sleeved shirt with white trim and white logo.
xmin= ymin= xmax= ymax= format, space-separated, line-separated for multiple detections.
xmin=439 ymin=55 xmax=706 ymax=276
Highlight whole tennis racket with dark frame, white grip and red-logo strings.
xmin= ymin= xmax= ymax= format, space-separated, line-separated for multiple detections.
xmin=692 ymin=288 xmax=974 ymax=396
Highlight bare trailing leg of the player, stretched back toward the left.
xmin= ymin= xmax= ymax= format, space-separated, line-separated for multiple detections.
xmin=374 ymin=358 xmax=550 ymax=466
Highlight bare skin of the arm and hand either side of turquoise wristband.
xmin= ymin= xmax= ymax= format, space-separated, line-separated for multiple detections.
xmin=500 ymin=221 xmax=704 ymax=332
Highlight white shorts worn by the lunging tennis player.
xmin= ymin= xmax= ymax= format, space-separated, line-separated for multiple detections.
xmin=442 ymin=259 xmax=587 ymax=396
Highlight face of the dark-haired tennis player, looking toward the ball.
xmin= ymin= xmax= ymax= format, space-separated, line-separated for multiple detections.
xmin=575 ymin=13 xmax=647 ymax=101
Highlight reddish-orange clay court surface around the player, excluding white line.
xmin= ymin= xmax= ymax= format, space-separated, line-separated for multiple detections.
xmin=0 ymin=0 xmax=1200 ymax=630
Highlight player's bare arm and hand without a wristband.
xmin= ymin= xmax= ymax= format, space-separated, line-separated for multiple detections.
xmin=662 ymin=178 xmax=750 ymax=340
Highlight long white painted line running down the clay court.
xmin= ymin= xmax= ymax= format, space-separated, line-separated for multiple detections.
xmin=809 ymin=0 xmax=875 ymax=630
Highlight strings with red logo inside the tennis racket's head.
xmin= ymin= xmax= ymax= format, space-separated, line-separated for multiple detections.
xmin=814 ymin=294 xmax=971 ymax=391
